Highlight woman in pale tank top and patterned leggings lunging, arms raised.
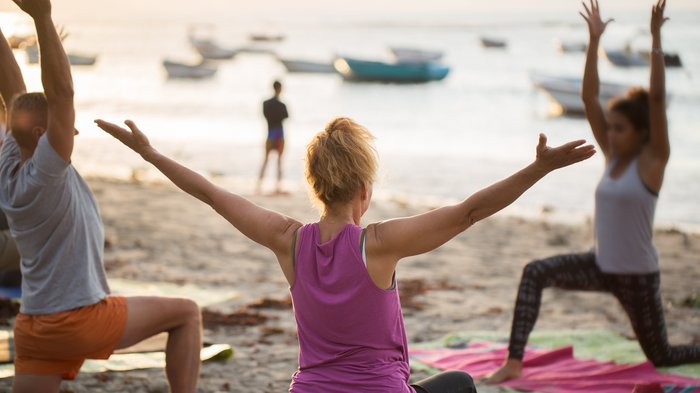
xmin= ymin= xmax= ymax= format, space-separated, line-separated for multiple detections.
xmin=485 ymin=0 xmax=700 ymax=384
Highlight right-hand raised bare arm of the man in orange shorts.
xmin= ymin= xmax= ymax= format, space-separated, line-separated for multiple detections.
xmin=13 ymin=0 xmax=75 ymax=162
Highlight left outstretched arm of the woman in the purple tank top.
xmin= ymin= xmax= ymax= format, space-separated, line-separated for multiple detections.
xmin=95 ymin=120 xmax=301 ymax=260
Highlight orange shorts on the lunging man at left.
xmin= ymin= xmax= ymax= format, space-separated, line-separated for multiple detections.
xmin=15 ymin=296 xmax=127 ymax=379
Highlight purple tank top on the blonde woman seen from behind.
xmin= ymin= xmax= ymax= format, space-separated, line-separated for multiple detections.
xmin=289 ymin=224 xmax=414 ymax=393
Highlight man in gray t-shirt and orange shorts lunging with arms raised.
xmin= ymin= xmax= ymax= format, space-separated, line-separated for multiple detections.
xmin=0 ymin=0 xmax=202 ymax=392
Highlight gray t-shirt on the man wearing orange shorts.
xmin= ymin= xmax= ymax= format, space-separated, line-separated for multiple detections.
xmin=0 ymin=134 xmax=109 ymax=315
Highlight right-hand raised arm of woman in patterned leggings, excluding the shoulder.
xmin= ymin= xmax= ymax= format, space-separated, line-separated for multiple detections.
xmin=649 ymin=0 xmax=671 ymax=164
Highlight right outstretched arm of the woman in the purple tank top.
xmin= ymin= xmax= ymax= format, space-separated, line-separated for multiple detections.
xmin=367 ymin=135 xmax=595 ymax=260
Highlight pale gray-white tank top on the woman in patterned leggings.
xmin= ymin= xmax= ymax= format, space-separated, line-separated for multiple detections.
xmin=595 ymin=159 xmax=659 ymax=274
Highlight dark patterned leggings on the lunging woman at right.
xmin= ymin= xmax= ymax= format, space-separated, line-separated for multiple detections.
xmin=508 ymin=253 xmax=700 ymax=367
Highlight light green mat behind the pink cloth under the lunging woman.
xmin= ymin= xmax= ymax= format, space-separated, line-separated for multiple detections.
xmin=411 ymin=330 xmax=700 ymax=378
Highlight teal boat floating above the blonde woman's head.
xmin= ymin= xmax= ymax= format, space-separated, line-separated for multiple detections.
xmin=333 ymin=57 xmax=450 ymax=83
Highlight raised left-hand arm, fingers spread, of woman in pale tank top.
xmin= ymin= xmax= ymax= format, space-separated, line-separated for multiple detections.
xmin=580 ymin=0 xmax=612 ymax=158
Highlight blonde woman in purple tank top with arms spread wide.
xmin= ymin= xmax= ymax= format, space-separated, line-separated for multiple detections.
xmin=97 ymin=111 xmax=595 ymax=393
